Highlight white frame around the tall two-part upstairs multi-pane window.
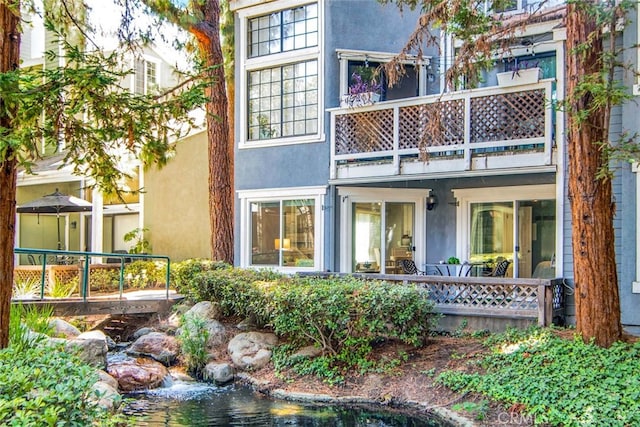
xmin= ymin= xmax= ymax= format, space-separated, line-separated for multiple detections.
xmin=236 ymin=0 xmax=325 ymax=150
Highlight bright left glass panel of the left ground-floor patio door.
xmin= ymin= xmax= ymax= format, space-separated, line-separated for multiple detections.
xmin=351 ymin=202 xmax=382 ymax=273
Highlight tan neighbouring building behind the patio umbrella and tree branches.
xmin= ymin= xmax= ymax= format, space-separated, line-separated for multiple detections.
xmin=16 ymin=4 xmax=210 ymax=264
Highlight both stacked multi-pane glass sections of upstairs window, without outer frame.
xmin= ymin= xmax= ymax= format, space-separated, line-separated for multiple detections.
xmin=245 ymin=3 xmax=320 ymax=141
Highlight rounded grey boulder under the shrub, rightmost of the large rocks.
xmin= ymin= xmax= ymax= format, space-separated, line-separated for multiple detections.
xmin=227 ymin=332 xmax=278 ymax=370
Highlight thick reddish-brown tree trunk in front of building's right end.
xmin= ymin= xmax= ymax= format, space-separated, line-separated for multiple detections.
xmin=567 ymin=4 xmax=622 ymax=347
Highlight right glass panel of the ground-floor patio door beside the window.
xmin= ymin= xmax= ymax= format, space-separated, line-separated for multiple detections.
xmin=383 ymin=202 xmax=415 ymax=274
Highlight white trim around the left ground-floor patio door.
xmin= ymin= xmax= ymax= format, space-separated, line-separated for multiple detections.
xmin=337 ymin=187 xmax=431 ymax=273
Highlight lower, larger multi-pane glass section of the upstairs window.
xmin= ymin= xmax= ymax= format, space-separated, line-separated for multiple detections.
xmin=249 ymin=60 xmax=318 ymax=140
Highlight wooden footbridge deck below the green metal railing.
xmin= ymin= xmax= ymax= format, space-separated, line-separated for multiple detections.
xmin=12 ymin=289 xmax=184 ymax=316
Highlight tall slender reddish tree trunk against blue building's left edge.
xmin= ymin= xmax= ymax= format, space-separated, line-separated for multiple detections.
xmin=190 ymin=0 xmax=233 ymax=264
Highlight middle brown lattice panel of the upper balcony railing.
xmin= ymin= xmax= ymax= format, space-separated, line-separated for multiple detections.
xmin=399 ymin=99 xmax=464 ymax=149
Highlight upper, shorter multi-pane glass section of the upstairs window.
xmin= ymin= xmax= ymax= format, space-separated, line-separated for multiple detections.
xmin=249 ymin=3 xmax=318 ymax=58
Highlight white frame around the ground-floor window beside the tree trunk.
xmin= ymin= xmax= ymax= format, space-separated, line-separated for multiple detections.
xmin=237 ymin=186 xmax=327 ymax=273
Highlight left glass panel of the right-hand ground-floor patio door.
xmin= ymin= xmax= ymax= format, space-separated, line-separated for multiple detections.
xmin=469 ymin=202 xmax=514 ymax=276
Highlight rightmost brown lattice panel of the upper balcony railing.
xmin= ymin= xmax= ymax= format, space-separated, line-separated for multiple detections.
xmin=471 ymin=89 xmax=545 ymax=143
